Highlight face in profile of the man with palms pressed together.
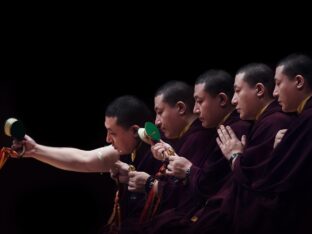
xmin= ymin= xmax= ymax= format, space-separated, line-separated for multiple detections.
xmin=232 ymin=73 xmax=261 ymax=120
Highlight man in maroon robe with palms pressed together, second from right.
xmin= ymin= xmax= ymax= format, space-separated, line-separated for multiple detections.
xmin=177 ymin=64 xmax=294 ymax=233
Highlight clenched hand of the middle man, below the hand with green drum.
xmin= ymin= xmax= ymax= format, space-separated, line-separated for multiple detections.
xmin=166 ymin=154 xmax=192 ymax=179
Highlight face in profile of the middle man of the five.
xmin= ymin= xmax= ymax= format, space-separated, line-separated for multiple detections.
xmin=193 ymin=83 xmax=225 ymax=128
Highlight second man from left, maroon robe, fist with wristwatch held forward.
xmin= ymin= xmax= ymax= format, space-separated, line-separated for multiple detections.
xmin=116 ymin=81 xmax=214 ymax=233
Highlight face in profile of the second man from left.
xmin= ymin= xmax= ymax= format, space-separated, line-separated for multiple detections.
xmin=154 ymin=94 xmax=184 ymax=139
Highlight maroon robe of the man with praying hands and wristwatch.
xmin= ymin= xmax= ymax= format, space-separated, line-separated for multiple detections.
xmin=183 ymin=102 xmax=295 ymax=234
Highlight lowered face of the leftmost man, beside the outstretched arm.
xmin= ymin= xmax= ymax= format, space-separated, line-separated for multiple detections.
xmin=105 ymin=117 xmax=139 ymax=155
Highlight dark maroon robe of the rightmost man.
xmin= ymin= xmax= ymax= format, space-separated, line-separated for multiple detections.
xmin=239 ymin=98 xmax=312 ymax=234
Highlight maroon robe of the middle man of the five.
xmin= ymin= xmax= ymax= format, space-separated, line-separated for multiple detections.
xmin=141 ymin=111 xmax=251 ymax=233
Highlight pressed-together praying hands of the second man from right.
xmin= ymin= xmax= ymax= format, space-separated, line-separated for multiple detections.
xmin=217 ymin=125 xmax=246 ymax=160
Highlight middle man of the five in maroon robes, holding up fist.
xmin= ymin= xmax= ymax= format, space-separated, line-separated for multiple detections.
xmin=143 ymin=70 xmax=251 ymax=233
